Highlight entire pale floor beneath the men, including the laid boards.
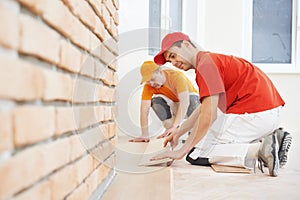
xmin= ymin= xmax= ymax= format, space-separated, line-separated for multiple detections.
xmin=103 ymin=133 xmax=300 ymax=200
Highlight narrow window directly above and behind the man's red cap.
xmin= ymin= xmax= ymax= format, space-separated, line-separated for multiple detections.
xmin=149 ymin=0 xmax=182 ymax=55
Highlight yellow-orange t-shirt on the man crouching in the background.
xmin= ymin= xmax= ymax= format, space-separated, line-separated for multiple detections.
xmin=142 ymin=69 xmax=198 ymax=102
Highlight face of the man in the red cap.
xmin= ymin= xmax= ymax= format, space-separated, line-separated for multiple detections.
xmin=164 ymin=42 xmax=193 ymax=71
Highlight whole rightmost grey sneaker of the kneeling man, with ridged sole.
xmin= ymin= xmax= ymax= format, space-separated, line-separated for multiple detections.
xmin=274 ymin=128 xmax=292 ymax=167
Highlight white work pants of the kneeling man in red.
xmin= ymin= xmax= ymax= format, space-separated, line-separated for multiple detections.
xmin=190 ymin=106 xmax=282 ymax=167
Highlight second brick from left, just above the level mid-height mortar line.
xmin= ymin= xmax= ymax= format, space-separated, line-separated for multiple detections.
xmin=43 ymin=70 xmax=73 ymax=101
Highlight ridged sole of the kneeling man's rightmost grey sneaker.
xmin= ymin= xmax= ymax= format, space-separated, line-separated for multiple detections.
xmin=278 ymin=132 xmax=292 ymax=167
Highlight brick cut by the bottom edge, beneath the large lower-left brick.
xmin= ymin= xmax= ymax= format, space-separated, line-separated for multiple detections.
xmin=14 ymin=181 xmax=52 ymax=200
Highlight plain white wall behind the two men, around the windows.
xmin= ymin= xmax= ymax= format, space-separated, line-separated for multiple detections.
xmin=119 ymin=0 xmax=300 ymax=135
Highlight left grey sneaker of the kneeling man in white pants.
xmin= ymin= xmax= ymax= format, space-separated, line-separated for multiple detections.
xmin=258 ymin=133 xmax=279 ymax=176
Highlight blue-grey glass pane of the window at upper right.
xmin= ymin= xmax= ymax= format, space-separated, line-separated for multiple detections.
xmin=252 ymin=0 xmax=293 ymax=64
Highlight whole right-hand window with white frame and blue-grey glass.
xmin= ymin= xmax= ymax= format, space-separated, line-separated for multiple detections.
xmin=244 ymin=0 xmax=300 ymax=72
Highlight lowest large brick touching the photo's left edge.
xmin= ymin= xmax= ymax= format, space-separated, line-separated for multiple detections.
xmin=0 ymin=139 xmax=70 ymax=199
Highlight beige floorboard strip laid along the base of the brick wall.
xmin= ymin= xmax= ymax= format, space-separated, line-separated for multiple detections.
xmin=101 ymin=136 xmax=171 ymax=200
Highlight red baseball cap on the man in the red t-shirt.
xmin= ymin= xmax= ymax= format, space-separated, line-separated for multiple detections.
xmin=154 ymin=32 xmax=190 ymax=65
